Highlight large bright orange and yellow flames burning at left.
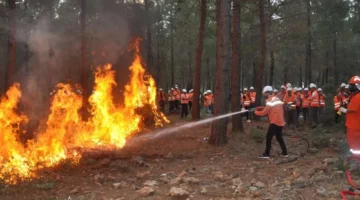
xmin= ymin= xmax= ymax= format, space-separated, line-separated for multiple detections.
xmin=0 ymin=40 xmax=169 ymax=184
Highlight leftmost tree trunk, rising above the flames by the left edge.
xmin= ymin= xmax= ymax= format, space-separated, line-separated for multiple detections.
xmin=5 ymin=0 xmax=16 ymax=88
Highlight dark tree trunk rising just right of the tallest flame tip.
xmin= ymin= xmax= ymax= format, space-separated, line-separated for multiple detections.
xmin=144 ymin=0 xmax=155 ymax=73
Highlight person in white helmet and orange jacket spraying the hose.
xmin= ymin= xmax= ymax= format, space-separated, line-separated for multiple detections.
xmin=255 ymin=86 xmax=289 ymax=159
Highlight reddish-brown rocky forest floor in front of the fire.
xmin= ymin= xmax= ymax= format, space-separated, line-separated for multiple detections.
xmin=0 ymin=113 xmax=354 ymax=200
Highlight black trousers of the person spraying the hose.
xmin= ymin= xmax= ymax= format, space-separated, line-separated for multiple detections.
xmin=265 ymin=124 xmax=287 ymax=155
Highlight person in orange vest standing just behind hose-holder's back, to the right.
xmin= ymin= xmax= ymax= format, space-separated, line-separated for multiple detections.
xmin=284 ymin=87 xmax=298 ymax=126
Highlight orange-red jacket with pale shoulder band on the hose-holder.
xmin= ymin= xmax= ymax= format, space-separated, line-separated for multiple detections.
xmin=255 ymin=95 xmax=285 ymax=126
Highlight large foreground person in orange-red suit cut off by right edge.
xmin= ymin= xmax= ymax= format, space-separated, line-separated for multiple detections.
xmin=339 ymin=76 xmax=360 ymax=156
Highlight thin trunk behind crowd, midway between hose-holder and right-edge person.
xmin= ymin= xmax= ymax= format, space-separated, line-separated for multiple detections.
xmin=305 ymin=0 xmax=312 ymax=84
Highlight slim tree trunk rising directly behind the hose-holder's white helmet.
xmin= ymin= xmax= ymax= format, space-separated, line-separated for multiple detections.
xmin=255 ymin=0 xmax=266 ymax=108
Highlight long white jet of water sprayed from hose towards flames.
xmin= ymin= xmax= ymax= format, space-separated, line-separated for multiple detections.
xmin=132 ymin=108 xmax=256 ymax=142
